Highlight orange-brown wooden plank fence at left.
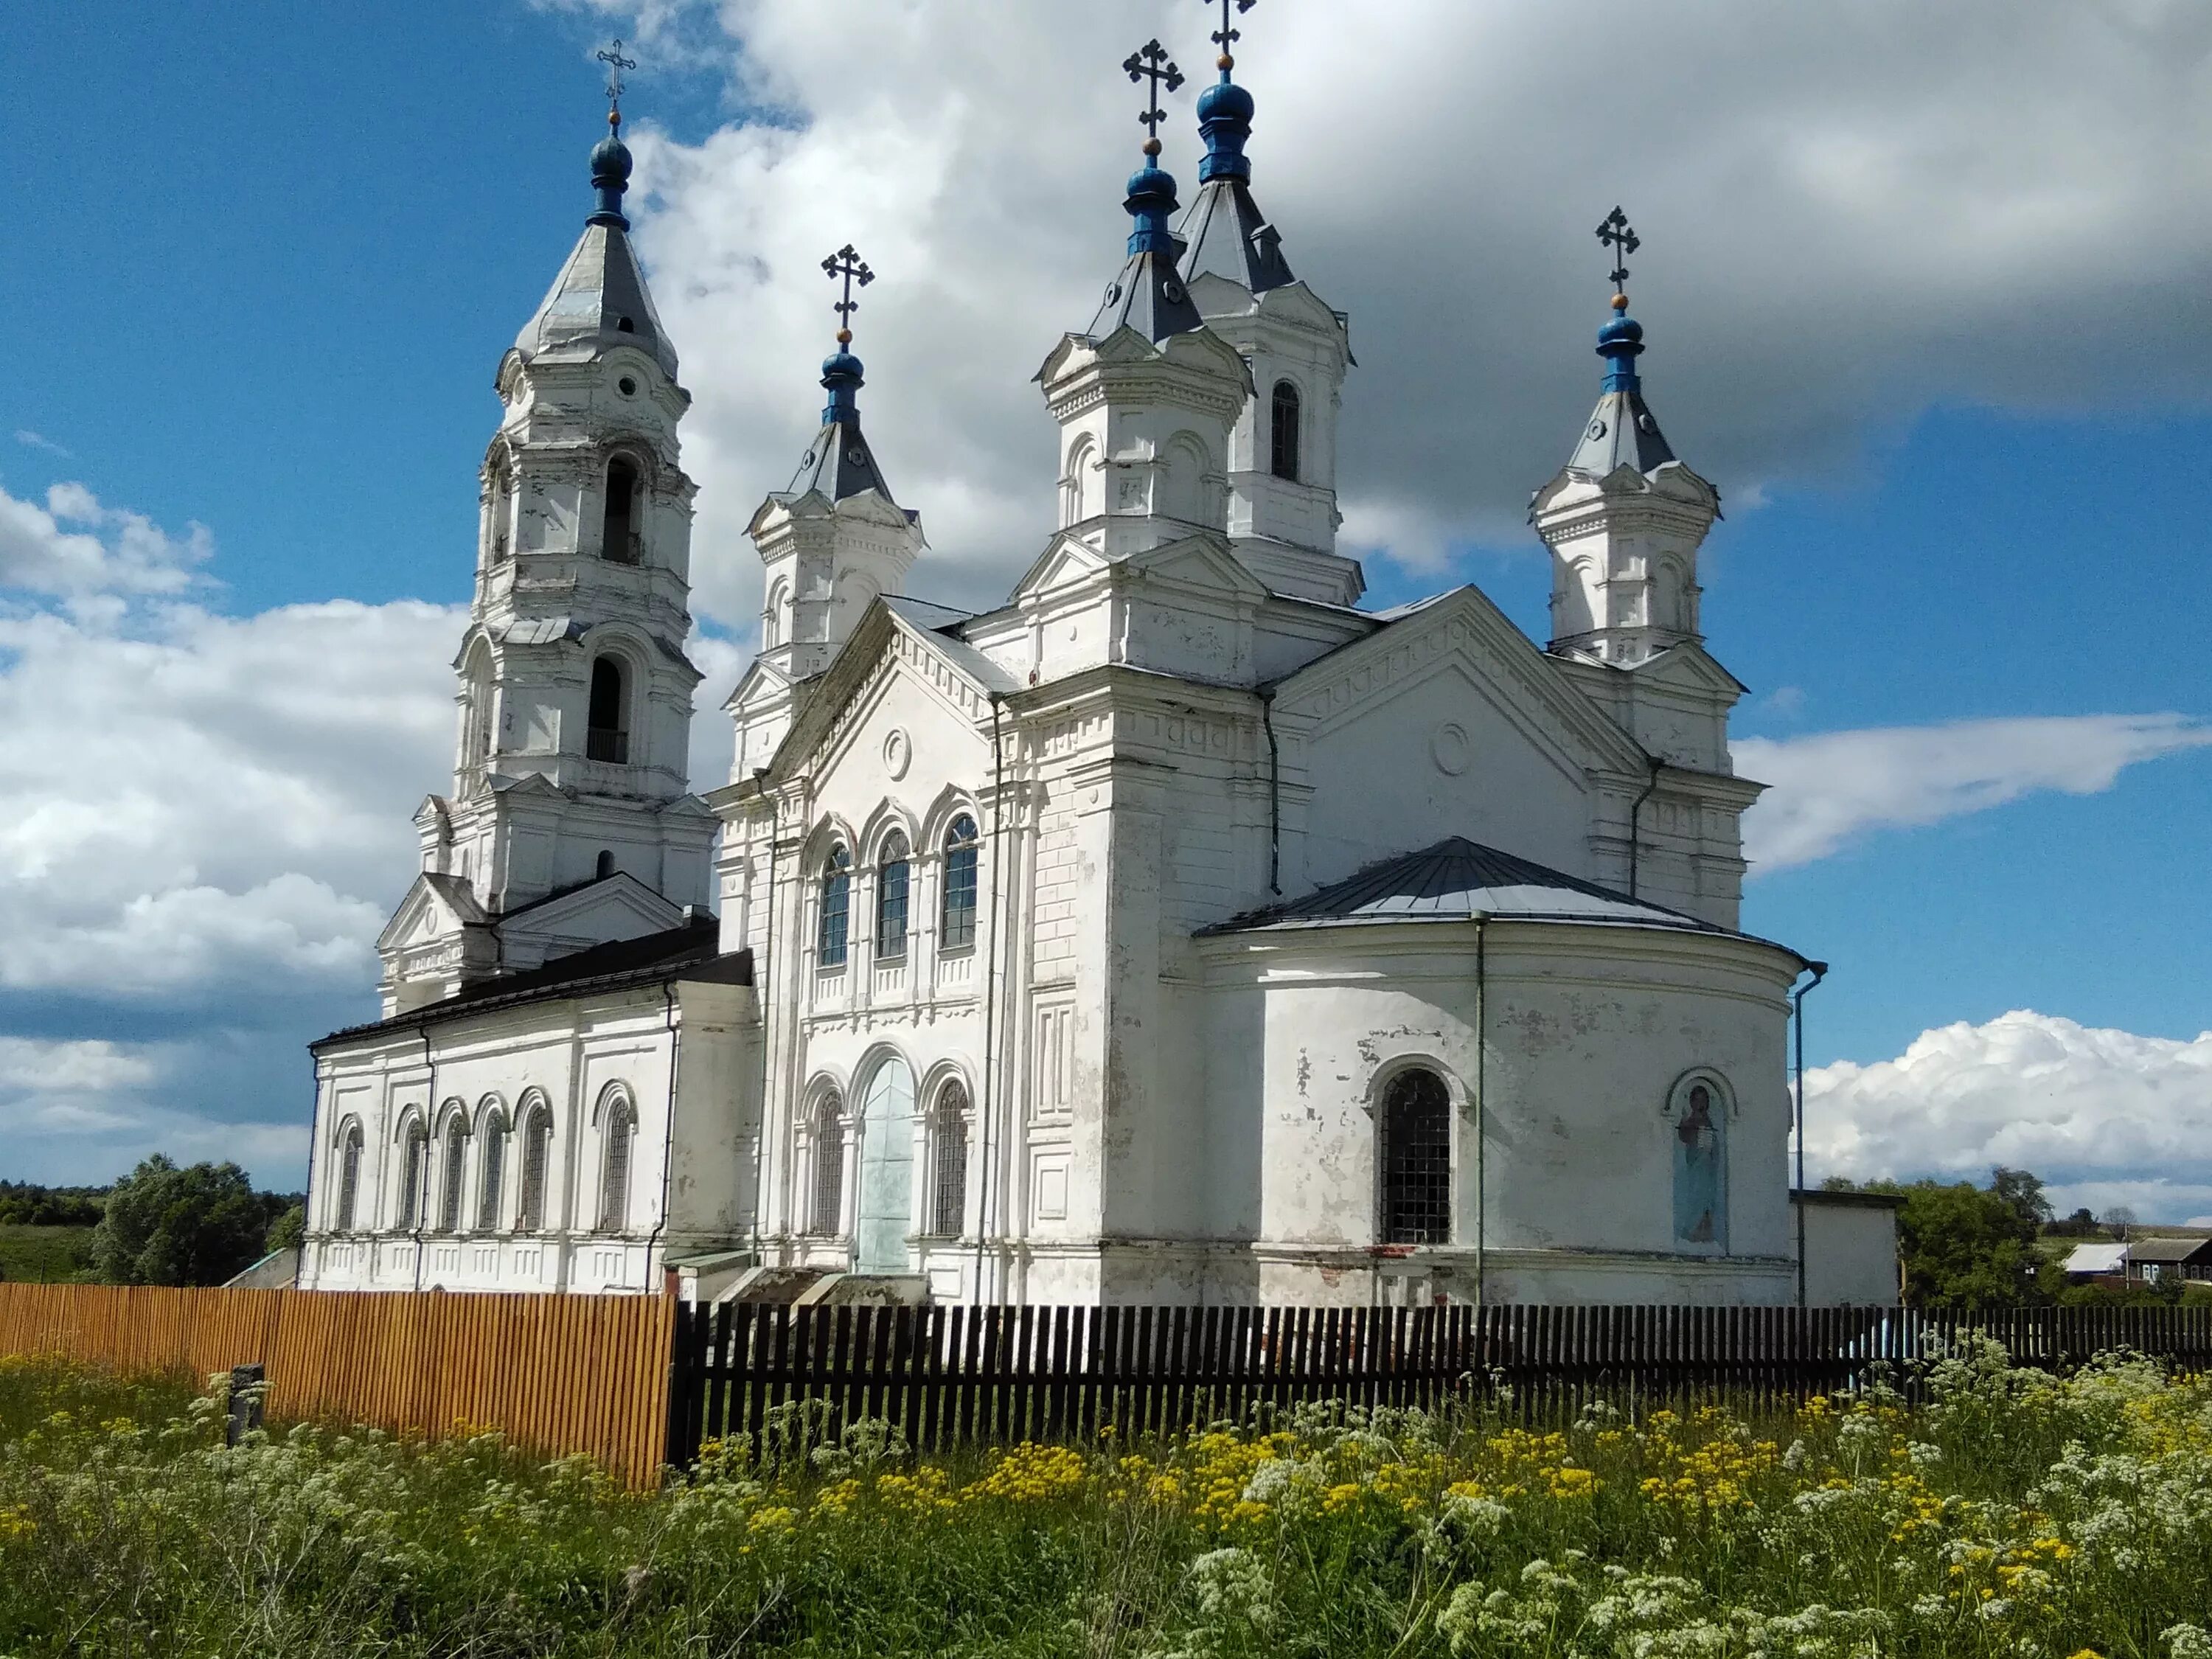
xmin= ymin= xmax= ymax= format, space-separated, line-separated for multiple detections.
xmin=0 ymin=1283 xmax=675 ymax=1486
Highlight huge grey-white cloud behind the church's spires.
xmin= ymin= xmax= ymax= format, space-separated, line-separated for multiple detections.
xmin=526 ymin=0 xmax=2212 ymax=630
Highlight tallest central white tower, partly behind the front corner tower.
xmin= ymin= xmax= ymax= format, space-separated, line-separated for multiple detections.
xmin=1177 ymin=0 xmax=1367 ymax=604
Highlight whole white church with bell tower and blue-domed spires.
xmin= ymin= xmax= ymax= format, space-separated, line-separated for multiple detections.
xmin=299 ymin=49 xmax=1896 ymax=1305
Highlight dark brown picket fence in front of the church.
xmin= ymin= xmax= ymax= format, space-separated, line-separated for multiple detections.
xmin=668 ymin=1305 xmax=2212 ymax=1464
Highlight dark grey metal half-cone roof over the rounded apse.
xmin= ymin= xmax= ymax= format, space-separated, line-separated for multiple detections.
xmin=1199 ymin=836 xmax=1732 ymax=936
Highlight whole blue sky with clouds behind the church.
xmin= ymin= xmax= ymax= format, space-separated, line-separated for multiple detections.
xmin=0 ymin=0 xmax=2212 ymax=1219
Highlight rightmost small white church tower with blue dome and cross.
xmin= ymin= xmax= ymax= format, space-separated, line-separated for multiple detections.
xmin=1528 ymin=208 xmax=1721 ymax=668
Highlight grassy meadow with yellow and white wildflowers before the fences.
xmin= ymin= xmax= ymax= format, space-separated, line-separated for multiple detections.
xmin=0 ymin=1352 xmax=2212 ymax=1659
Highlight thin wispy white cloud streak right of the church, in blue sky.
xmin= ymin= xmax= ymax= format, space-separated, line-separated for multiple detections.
xmin=1730 ymin=714 xmax=2212 ymax=869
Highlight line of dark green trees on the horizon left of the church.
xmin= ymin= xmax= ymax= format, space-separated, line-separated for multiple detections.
xmin=0 ymin=1152 xmax=307 ymax=1285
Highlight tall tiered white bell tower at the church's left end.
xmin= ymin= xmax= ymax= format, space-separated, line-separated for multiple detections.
xmin=378 ymin=84 xmax=714 ymax=1015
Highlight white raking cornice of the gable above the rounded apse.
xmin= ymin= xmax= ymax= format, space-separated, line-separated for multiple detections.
xmin=1276 ymin=586 xmax=1648 ymax=772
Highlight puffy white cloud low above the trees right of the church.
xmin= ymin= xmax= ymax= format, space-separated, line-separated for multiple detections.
xmin=1805 ymin=1009 xmax=2212 ymax=1221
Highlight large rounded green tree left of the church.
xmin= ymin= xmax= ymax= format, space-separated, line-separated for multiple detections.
xmin=93 ymin=1152 xmax=270 ymax=1285
